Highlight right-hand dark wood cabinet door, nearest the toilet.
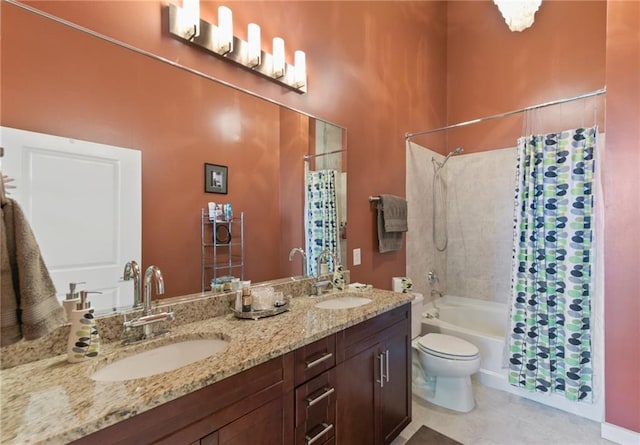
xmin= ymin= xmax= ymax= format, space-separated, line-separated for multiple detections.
xmin=380 ymin=323 xmax=411 ymax=444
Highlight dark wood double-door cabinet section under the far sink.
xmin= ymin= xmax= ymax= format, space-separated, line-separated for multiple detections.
xmin=336 ymin=305 xmax=411 ymax=445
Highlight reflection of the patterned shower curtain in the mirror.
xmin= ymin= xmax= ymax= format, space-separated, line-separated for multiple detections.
xmin=305 ymin=170 xmax=340 ymax=276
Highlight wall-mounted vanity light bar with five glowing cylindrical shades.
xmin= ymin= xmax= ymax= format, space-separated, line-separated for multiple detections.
xmin=169 ymin=0 xmax=307 ymax=93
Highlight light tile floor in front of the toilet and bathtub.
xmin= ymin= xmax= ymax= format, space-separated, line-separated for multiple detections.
xmin=392 ymin=383 xmax=613 ymax=445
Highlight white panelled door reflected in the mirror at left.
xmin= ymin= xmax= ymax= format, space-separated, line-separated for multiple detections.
xmin=0 ymin=127 xmax=142 ymax=313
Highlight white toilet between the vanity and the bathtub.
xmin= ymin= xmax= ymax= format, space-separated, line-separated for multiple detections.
xmin=411 ymin=294 xmax=480 ymax=413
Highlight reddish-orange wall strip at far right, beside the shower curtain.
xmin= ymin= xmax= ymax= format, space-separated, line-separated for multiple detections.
xmin=604 ymin=1 xmax=640 ymax=434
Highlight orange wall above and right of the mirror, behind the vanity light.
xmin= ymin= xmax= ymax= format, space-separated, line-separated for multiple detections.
xmin=3 ymin=1 xmax=446 ymax=288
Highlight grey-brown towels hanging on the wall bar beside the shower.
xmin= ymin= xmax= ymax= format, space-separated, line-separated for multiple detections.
xmin=377 ymin=195 xmax=407 ymax=253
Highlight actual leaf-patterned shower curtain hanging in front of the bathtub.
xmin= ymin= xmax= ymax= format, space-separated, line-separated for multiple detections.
xmin=509 ymin=127 xmax=597 ymax=401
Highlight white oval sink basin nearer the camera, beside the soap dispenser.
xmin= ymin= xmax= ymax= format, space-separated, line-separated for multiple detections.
xmin=91 ymin=339 xmax=229 ymax=382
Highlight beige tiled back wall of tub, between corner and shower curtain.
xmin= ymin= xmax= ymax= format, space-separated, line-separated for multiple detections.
xmin=445 ymin=148 xmax=516 ymax=303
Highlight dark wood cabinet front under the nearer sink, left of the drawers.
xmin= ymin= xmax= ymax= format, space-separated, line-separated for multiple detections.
xmin=74 ymin=353 xmax=293 ymax=445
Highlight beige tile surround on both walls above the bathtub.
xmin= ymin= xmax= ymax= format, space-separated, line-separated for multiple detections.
xmin=406 ymin=144 xmax=516 ymax=303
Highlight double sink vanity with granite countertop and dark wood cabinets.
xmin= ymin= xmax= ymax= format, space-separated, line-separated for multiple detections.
xmin=0 ymin=279 xmax=411 ymax=445
